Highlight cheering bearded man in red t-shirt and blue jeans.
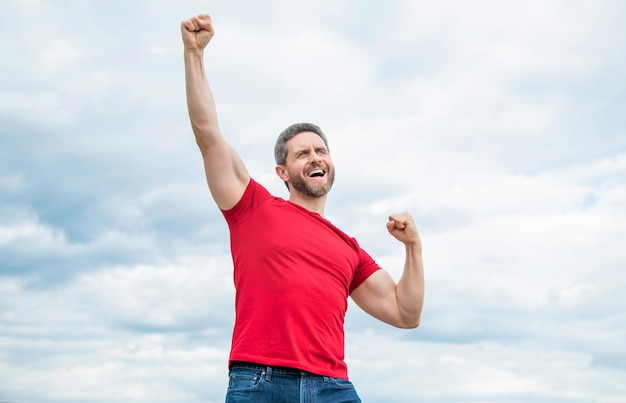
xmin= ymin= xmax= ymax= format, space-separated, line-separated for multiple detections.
xmin=181 ymin=15 xmax=424 ymax=403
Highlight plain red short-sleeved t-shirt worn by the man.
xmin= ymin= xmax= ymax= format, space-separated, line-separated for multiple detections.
xmin=223 ymin=179 xmax=379 ymax=379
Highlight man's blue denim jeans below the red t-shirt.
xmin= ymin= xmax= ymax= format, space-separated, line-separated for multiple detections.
xmin=226 ymin=363 xmax=361 ymax=403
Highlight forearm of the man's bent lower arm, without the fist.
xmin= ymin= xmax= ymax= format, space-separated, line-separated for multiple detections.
xmin=396 ymin=244 xmax=424 ymax=328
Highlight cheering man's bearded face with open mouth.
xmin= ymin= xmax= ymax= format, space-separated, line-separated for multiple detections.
xmin=285 ymin=132 xmax=335 ymax=197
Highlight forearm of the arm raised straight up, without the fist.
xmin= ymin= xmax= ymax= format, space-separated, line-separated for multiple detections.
xmin=184 ymin=49 xmax=221 ymax=150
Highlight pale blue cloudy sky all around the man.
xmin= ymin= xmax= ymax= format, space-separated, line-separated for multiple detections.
xmin=0 ymin=0 xmax=626 ymax=403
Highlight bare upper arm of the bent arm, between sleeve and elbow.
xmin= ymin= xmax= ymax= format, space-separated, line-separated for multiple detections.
xmin=350 ymin=269 xmax=399 ymax=326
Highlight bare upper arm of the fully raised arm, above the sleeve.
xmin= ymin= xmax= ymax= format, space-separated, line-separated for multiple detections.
xmin=202 ymin=141 xmax=250 ymax=210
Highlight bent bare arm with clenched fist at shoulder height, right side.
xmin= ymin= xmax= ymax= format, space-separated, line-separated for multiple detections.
xmin=351 ymin=213 xmax=424 ymax=329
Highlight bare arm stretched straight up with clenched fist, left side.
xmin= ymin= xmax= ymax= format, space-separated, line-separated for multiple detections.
xmin=180 ymin=14 xmax=250 ymax=210
